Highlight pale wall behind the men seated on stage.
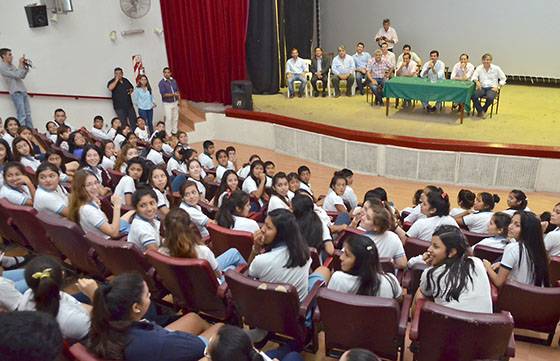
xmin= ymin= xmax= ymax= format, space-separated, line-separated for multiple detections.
xmin=320 ymin=0 xmax=560 ymax=78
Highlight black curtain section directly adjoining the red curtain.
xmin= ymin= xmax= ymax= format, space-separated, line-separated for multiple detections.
xmin=246 ymin=0 xmax=279 ymax=94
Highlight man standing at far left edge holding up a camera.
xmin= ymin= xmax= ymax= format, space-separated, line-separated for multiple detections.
xmin=0 ymin=48 xmax=33 ymax=129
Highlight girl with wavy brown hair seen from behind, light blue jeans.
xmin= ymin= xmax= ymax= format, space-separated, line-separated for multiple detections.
xmin=161 ymin=208 xmax=247 ymax=283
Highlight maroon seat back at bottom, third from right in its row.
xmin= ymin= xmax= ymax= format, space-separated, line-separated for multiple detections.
xmin=317 ymin=288 xmax=400 ymax=360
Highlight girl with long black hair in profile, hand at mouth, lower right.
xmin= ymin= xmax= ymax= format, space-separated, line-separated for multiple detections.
xmin=416 ymin=225 xmax=492 ymax=313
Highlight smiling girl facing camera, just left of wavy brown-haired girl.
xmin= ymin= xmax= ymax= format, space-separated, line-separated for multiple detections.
xmin=127 ymin=186 xmax=161 ymax=252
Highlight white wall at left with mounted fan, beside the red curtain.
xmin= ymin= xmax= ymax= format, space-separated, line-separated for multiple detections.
xmin=0 ymin=0 xmax=167 ymax=128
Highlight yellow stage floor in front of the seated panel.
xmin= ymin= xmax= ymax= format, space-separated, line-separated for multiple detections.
xmin=253 ymin=85 xmax=560 ymax=147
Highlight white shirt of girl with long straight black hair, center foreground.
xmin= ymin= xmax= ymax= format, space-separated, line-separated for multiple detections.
xmin=248 ymin=246 xmax=311 ymax=302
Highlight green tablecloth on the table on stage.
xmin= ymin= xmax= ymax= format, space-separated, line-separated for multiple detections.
xmin=383 ymin=76 xmax=474 ymax=112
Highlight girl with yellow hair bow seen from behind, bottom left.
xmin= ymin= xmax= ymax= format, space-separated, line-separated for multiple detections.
xmin=18 ymin=256 xmax=90 ymax=341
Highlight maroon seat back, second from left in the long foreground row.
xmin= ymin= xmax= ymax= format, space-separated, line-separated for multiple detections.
xmin=37 ymin=211 xmax=105 ymax=279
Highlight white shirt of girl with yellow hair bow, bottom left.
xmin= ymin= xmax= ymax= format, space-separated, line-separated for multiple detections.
xmin=17 ymin=289 xmax=90 ymax=340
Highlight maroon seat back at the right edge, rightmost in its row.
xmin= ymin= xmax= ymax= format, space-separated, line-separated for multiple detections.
xmin=497 ymin=281 xmax=560 ymax=333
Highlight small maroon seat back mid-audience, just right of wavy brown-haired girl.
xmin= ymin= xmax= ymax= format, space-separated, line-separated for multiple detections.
xmin=206 ymin=223 xmax=253 ymax=260
